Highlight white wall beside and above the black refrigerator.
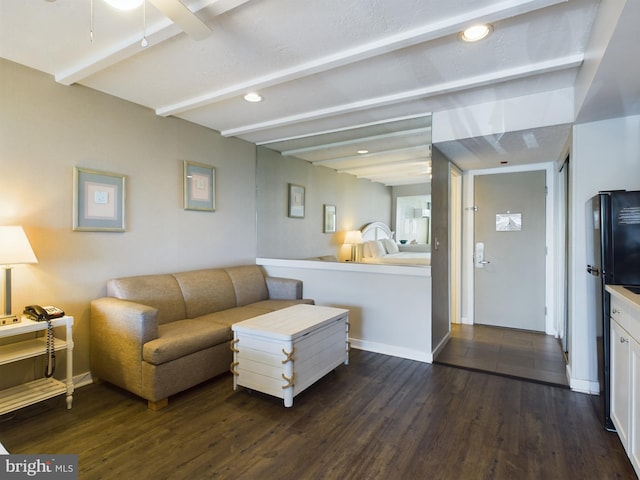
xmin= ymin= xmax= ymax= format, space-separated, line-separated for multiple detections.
xmin=569 ymin=116 xmax=640 ymax=393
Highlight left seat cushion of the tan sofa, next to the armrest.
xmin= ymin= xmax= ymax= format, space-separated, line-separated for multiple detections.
xmin=142 ymin=319 xmax=231 ymax=365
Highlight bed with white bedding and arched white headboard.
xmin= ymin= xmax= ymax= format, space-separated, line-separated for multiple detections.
xmin=360 ymin=222 xmax=431 ymax=266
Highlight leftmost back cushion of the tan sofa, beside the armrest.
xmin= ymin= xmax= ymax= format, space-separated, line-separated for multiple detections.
xmin=107 ymin=274 xmax=186 ymax=324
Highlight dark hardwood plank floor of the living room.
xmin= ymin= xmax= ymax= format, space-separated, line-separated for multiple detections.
xmin=0 ymin=350 xmax=636 ymax=480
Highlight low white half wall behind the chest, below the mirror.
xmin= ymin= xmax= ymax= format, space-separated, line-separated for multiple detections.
xmin=257 ymin=258 xmax=433 ymax=362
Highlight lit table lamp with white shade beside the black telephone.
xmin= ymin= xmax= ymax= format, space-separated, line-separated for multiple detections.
xmin=0 ymin=226 xmax=38 ymax=325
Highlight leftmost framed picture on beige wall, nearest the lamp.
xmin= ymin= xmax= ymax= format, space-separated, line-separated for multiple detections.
xmin=73 ymin=167 xmax=125 ymax=232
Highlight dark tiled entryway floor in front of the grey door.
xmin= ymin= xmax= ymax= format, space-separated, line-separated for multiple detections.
xmin=436 ymin=324 xmax=569 ymax=387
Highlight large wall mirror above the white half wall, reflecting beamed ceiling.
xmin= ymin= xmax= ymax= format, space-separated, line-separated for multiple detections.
xmin=256 ymin=115 xmax=431 ymax=261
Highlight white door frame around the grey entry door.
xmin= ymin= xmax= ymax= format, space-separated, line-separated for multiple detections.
xmin=462 ymin=162 xmax=557 ymax=336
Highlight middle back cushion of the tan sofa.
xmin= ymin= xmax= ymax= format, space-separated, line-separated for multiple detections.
xmin=174 ymin=268 xmax=236 ymax=318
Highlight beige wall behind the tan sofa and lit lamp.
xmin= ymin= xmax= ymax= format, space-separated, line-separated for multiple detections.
xmin=0 ymin=60 xmax=256 ymax=386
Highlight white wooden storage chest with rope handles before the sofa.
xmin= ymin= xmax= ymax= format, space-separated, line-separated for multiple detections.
xmin=231 ymin=305 xmax=349 ymax=407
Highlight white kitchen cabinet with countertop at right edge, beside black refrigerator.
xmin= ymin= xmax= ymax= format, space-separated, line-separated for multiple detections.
xmin=607 ymin=285 xmax=640 ymax=476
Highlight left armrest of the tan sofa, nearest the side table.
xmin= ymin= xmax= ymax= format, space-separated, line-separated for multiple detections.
xmin=89 ymin=297 xmax=158 ymax=395
